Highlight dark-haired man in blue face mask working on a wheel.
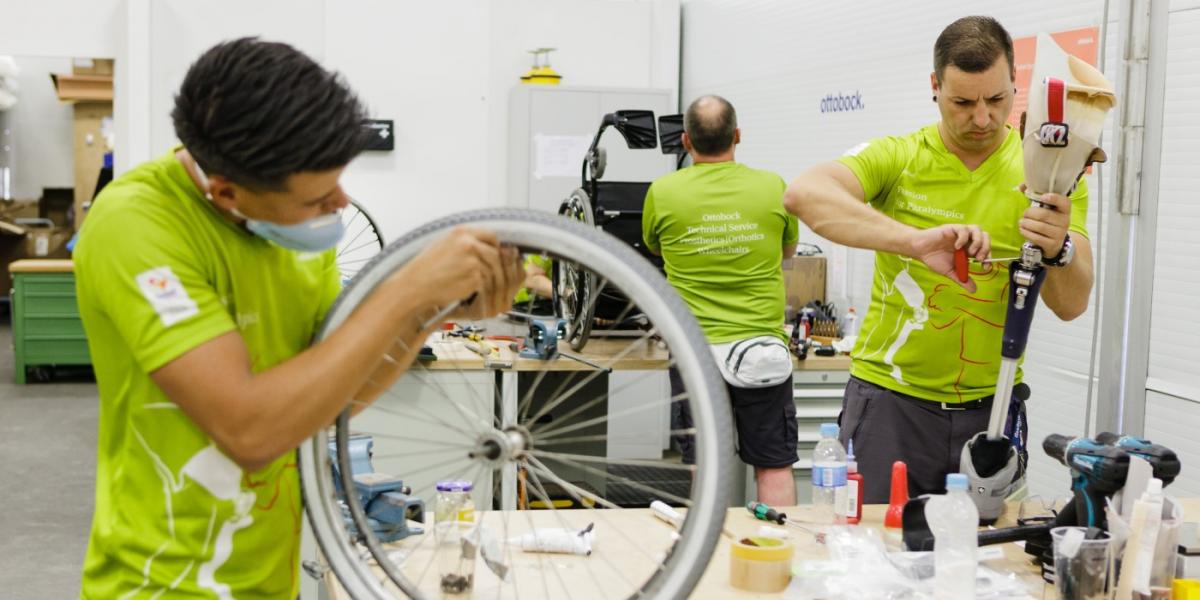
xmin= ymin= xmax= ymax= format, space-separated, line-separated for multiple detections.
xmin=74 ymin=38 xmax=523 ymax=599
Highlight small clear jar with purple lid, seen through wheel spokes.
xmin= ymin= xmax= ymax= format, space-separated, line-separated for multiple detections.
xmin=433 ymin=480 xmax=476 ymax=594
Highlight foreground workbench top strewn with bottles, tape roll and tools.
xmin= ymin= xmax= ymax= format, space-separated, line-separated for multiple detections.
xmin=326 ymin=499 xmax=1200 ymax=600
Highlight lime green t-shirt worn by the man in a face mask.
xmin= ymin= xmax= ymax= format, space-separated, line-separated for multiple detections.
xmin=74 ymin=148 xmax=341 ymax=600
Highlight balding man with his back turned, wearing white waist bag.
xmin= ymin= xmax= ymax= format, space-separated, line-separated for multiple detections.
xmin=642 ymin=96 xmax=799 ymax=506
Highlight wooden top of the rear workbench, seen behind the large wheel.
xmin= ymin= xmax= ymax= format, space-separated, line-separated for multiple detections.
xmin=425 ymin=337 xmax=850 ymax=371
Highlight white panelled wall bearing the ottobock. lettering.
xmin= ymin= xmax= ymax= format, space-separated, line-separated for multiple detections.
xmin=682 ymin=0 xmax=1115 ymax=494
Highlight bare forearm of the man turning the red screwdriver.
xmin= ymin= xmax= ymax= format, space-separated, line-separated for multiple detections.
xmin=784 ymin=163 xmax=916 ymax=256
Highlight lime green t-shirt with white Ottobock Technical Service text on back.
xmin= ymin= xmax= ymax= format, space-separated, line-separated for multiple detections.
xmin=642 ymin=161 xmax=799 ymax=343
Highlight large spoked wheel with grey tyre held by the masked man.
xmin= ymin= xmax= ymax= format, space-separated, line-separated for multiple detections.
xmin=298 ymin=209 xmax=733 ymax=599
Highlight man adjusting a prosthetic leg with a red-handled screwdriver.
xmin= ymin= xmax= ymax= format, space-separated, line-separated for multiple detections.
xmin=785 ymin=17 xmax=1093 ymax=503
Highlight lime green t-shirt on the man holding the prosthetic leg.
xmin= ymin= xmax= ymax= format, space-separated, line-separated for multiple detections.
xmin=840 ymin=125 xmax=1087 ymax=402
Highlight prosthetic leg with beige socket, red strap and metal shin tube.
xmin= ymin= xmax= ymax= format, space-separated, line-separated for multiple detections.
xmin=960 ymin=34 xmax=1116 ymax=523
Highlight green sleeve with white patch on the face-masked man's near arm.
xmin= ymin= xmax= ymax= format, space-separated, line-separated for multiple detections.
xmin=77 ymin=210 xmax=236 ymax=373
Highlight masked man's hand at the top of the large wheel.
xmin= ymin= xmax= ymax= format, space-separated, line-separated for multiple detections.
xmin=394 ymin=226 xmax=524 ymax=319
